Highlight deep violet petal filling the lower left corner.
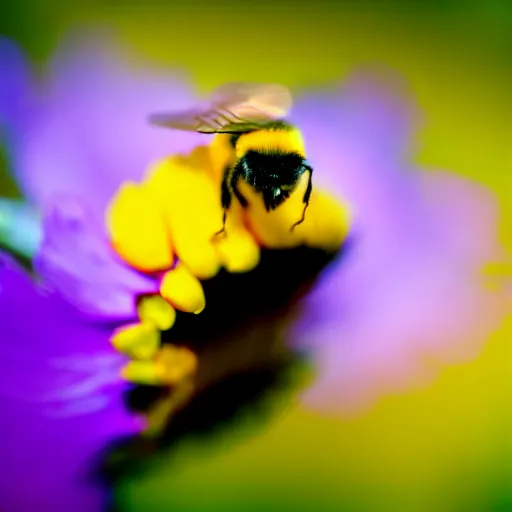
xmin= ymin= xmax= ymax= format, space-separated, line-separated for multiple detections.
xmin=0 ymin=255 xmax=139 ymax=512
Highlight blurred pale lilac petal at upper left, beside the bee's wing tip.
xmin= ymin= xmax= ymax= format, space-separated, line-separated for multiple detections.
xmin=7 ymin=34 xmax=206 ymax=222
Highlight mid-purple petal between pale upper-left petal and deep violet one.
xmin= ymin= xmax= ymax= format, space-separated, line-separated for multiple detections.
xmin=34 ymin=196 xmax=158 ymax=322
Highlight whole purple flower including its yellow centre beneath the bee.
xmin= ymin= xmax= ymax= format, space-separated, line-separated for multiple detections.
xmin=0 ymin=31 xmax=510 ymax=510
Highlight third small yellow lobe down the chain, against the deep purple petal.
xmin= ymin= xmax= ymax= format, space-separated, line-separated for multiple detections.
xmin=110 ymin=322 xmax=160 ymax=359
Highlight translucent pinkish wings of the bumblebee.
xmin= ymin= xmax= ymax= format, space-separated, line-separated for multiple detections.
xmin=149 ymin=82 xmax=292 ymax=133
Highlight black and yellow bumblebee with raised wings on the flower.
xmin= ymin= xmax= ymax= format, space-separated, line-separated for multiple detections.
xmin=150 ymin=83 xmax=313 ymax=235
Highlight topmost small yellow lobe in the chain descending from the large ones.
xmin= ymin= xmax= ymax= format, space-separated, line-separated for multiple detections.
xmin=160 ymin=263 xmax=206 ymax=314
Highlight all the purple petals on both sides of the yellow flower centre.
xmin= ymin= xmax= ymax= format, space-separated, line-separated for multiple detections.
xmin=0 ymin=31 xmax=510 ymax=511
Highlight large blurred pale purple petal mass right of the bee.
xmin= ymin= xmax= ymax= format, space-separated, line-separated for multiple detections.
xmin=290 ymin=76 xmax=512 ymax=413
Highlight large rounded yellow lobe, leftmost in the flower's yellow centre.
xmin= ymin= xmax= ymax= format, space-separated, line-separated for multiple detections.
xmin=106 ymin=183 xmax=173 ymax=272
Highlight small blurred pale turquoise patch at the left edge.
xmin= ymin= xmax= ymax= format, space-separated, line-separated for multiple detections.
xmin=0 ymin=199 xmax=43 ymax=259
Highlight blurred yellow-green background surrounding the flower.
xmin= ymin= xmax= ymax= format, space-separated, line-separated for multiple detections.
xmin=0 ymin=0 xmax=512 ymax=512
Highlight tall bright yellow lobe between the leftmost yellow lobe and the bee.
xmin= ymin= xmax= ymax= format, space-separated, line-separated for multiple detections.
xmin=147 ymin=156 xmax=223 ymax=279
